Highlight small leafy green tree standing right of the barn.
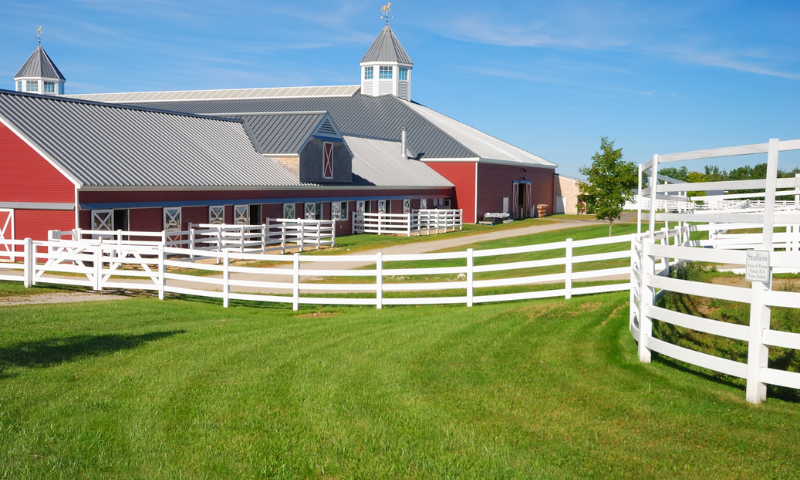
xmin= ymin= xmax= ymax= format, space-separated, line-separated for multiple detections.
xmin=580 ymin=137 xmax=638 ymax=237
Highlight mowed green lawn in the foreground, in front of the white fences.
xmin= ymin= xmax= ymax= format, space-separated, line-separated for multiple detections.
xmin=0 ymin=287 xmax=800 ymax=479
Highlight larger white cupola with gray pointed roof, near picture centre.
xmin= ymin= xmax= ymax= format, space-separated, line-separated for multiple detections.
xmin=361 ymin=24 xmax=414 ymax=100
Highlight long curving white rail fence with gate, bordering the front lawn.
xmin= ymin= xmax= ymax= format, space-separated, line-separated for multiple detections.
xmin=0 ymin=230 xmax=648 ymax=309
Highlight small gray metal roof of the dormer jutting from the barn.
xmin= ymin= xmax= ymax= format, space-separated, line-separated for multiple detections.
xmin=220 ymin=112 xmax=328 ymax=155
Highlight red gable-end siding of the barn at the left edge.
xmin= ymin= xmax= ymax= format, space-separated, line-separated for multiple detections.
xmin=0 ymin=124 xmax=75 ymax=203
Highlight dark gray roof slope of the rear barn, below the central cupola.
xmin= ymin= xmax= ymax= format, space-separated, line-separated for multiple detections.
xmin=119 ymin=95 xmax=478 ymax=159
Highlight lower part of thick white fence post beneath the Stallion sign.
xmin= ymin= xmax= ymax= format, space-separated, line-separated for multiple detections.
xmin=745 ymin=280 xmax=771 ymax=403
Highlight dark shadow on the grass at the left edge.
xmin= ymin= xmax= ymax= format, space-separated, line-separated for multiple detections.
xmin=0 ymin=330 xmax=186 ymax=379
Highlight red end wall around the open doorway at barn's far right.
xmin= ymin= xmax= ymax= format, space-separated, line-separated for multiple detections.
xmin=476 ymin=163 xmax=555 ymax=219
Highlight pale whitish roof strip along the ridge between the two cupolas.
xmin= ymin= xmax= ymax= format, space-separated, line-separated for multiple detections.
xmin=70 ymin=85 xmax=360 ymax=104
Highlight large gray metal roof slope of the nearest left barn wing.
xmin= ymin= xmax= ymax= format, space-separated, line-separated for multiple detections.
xmin=0 ymin=90 xmax=300 ymax=187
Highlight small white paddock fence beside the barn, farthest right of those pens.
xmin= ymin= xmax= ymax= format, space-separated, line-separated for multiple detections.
xmin=353 ymin=209 xmax=463 ymax=237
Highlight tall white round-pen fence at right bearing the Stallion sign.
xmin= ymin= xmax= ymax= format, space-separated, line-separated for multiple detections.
xmin=630 ymin=139 xmax=800 ymax=403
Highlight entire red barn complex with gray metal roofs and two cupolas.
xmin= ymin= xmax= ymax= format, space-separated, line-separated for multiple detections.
xmin=0 ymin=25 xmax=555 ymax=242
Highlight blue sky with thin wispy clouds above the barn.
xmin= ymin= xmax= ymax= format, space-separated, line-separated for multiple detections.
xmin=0 ymin=0 xmax=800 ymax=176
